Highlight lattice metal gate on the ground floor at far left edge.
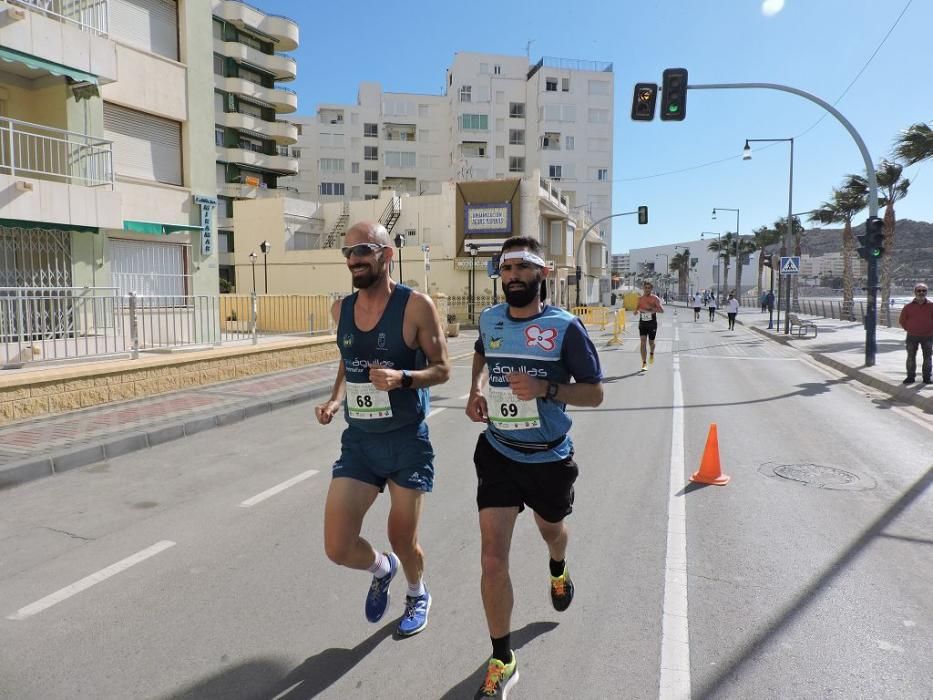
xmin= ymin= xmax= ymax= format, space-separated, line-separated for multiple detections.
xmin=0 ymin=226 xmax=72 ymax=289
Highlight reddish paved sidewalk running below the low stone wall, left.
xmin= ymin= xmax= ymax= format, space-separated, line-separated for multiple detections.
xmin=0 ymin=331 xmax=476 ymax=489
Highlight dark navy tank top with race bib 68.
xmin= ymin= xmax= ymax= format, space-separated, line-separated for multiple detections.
xmin=337 ymin=284 xmax=430 ymax=433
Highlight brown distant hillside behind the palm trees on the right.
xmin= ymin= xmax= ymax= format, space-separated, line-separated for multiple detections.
xmin=768 ymin=219 xmax=933 ymax=285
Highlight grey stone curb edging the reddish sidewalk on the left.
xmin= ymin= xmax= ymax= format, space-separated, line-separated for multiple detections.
xmin=0 ymin=350 xmax=473 ymax=490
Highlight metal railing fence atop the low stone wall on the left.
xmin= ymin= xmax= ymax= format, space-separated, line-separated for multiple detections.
xmin=0 ymin=287 xmax=339 ymax=369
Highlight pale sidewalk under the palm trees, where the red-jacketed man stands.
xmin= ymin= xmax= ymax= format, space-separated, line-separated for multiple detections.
xmin=728 ymin=306 xmax=933 ymax=415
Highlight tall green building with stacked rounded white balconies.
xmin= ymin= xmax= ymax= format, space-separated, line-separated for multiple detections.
xmin=211 ymin=0 xmax=300 ymax=289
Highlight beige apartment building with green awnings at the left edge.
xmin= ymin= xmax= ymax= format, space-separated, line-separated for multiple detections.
xmin=0 ymin=0 xmax=217 ymax=298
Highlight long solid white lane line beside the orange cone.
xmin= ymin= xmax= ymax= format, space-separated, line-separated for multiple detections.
xmin=658 ymin=326 xmax=690 ymax=700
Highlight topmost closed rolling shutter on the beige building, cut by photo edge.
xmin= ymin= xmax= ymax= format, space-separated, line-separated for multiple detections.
xmin=110 ymin=0 xmax=178 ymax=61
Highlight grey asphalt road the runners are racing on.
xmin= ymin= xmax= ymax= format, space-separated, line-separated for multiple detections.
xmin=0 ymin=313 xmax=933 ymax=700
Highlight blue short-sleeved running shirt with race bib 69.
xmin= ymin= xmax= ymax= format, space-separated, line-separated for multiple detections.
xmin=475 ymin=304 xmax=602 ymax=462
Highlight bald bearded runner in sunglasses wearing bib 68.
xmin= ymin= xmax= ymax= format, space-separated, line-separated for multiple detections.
xmin=314 ymin=221 xmax=450 ymax=637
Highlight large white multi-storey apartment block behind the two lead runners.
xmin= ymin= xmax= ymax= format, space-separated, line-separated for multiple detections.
xmin=287 ymin=53 xmax=614 ymax=246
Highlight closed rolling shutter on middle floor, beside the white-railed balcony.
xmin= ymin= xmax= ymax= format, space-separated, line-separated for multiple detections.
xmin=104 ymin=102 xmax=182 ymax=185
